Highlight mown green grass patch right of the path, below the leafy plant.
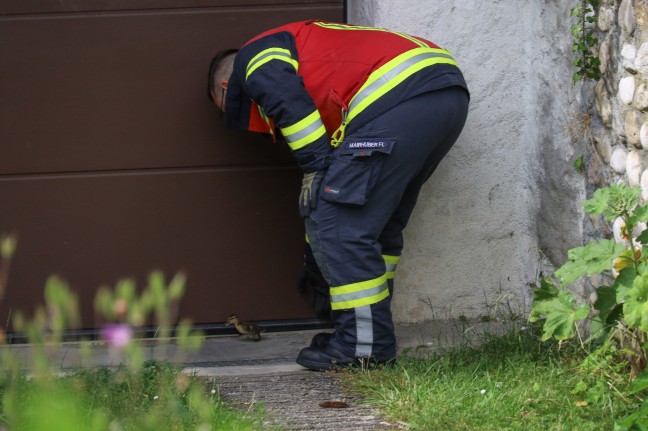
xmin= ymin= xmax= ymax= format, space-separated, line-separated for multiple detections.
xmin=342 ymin=329 xmax=639 ymax=431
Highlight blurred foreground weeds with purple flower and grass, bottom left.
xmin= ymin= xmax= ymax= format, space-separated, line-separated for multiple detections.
xmin=0 ymin=236 xmax=264 ymax=431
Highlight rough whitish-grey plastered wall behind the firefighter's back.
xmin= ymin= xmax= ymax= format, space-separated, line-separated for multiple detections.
xmin=348 ymin=0 xmax=586 ymax=323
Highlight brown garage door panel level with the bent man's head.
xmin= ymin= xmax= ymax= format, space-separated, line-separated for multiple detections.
xmin=0 ymin=5 xmax=340 ymax=174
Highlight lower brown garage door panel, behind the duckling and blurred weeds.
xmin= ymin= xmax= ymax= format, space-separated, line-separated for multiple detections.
xmin=0 ymin=167 xmax=313 ymax=327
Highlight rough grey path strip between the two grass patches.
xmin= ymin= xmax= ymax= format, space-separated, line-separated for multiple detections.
xmin=214 ymin=371 xmax=402 ymax=431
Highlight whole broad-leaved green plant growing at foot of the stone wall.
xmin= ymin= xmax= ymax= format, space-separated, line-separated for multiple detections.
xmin=530 ymin=184 xmax=648 ymax=430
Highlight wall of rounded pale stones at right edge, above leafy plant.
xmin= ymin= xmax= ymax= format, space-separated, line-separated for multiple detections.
xmin=588 ymin=0 xmax=648 ymax=206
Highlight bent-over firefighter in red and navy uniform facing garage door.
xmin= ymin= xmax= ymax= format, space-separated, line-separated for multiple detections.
xmin=208 ymin=21 xmax=469 ymax=370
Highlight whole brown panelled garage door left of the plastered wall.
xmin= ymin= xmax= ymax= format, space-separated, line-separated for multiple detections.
xmin=0 ymin=0 xmax=343 ymax=334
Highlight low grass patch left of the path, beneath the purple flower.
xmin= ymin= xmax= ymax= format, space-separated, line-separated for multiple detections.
xmin=0 ymin=361 xmax=264 ymax=431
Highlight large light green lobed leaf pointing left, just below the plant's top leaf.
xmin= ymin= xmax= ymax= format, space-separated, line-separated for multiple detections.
xmin=555 ymin=239 xmax=626 ymax=287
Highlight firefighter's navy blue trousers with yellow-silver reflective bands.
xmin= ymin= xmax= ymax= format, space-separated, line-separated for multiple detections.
xmin=305 ymin=87 xmax=469 ymax=360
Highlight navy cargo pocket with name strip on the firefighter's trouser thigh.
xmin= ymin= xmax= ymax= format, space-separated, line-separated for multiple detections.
xmin=320 ymin=138 xmax=396 ymax=206
